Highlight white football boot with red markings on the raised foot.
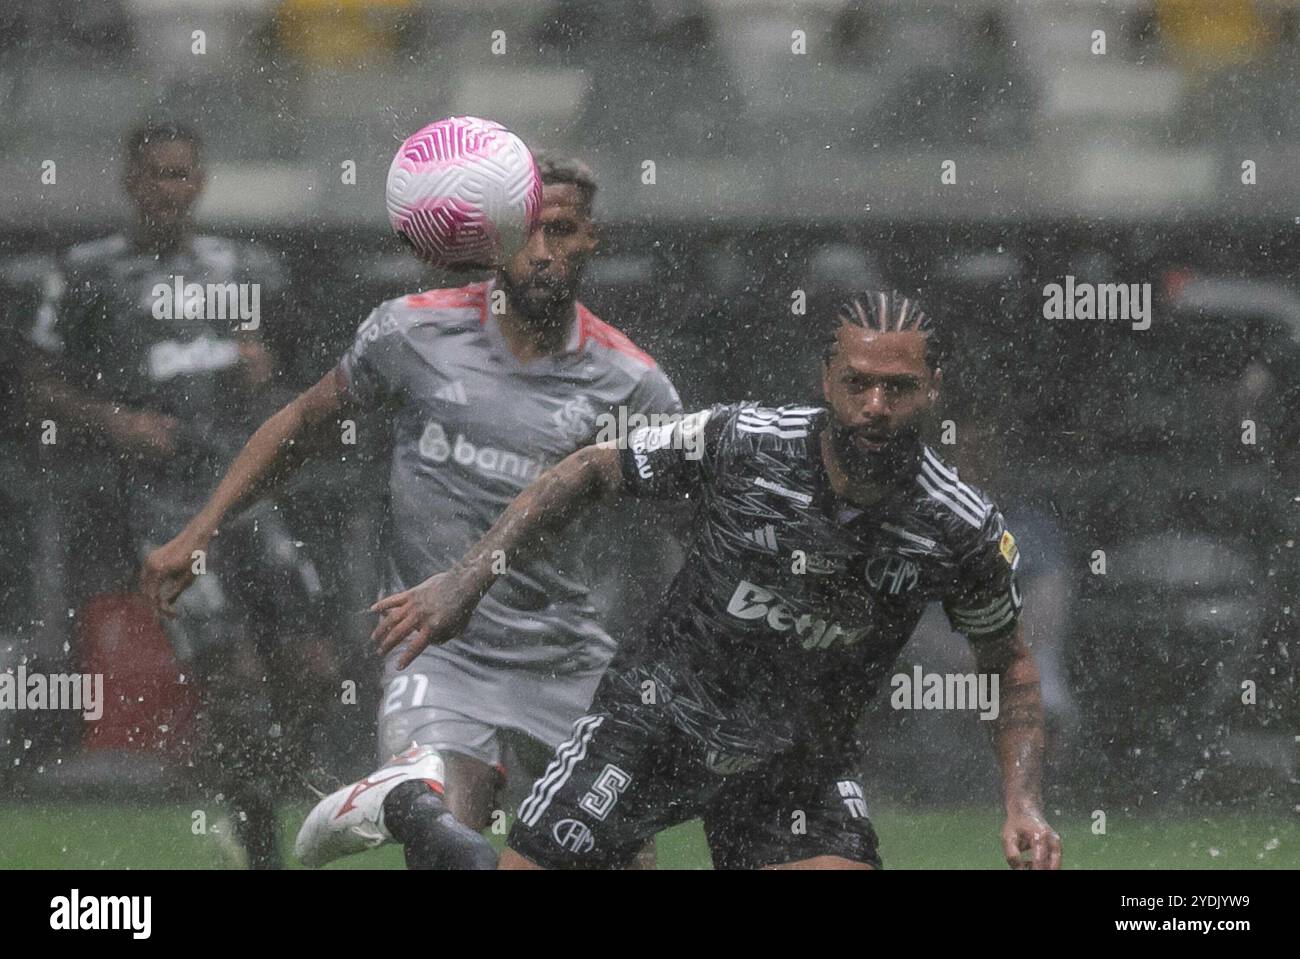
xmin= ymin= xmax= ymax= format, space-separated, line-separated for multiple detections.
xmin=294 ymin=746 xmax=443 ymax=869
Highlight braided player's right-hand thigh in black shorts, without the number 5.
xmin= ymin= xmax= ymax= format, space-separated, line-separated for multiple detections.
xmin=703 ymin=758 xmax=880 ymax=869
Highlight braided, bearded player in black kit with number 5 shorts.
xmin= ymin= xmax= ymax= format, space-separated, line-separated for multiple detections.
xmin=373 ymin=292 xmax=1061 ymax=869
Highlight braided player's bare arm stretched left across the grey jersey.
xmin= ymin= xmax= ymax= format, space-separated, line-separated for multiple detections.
xmin=371 ymin=443 xmax=623 ymax=669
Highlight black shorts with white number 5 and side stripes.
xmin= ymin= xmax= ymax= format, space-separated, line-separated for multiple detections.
xmin=508 ymin=674 xmax=880 ymax=869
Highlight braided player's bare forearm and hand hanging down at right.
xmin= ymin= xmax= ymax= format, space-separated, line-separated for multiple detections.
xmin=972 ymin=622 xmax=1061 ymax=869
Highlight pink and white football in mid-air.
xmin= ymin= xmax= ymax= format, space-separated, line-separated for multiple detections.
xmin=385 ymin=117 xmax=542 ymax=268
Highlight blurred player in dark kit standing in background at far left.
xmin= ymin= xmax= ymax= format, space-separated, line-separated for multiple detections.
xmin=23 ymin=122 xmax=330 ymax=868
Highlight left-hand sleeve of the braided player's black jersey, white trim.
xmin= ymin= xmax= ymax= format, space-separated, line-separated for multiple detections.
xmin=619 ymin=407 xmax=731 ymax=499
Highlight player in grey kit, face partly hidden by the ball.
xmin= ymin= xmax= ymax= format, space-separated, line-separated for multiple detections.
xmin=143 ymin=157 xmax=681 ymax=868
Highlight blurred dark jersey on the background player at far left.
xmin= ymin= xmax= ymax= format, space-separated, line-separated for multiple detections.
xmin=29 ymin=234 xmax=286 ymax=495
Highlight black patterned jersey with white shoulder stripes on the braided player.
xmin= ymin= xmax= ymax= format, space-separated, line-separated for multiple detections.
xmin=615 ymin=404 xmax=1021 ymax=763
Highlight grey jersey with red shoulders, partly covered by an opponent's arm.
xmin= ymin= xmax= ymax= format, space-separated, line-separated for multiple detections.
xmin=338 ymin=283 xmax=681 ymax=673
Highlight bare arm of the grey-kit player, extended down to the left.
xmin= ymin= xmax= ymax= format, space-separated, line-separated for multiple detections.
xmin=139 ymin=370 xmax=347 ymax=619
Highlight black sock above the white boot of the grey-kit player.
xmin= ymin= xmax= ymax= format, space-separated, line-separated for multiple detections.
xmin=384 ymin=780 xmax=497 ymax=869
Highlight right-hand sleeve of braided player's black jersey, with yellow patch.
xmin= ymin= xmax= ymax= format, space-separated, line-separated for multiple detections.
xmin=944 ymin=508 xmax=1021 ymax=639
